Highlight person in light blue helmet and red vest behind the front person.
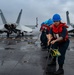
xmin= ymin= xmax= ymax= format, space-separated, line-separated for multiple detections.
xmin=40 ymin=19 xmax=53 ymax=49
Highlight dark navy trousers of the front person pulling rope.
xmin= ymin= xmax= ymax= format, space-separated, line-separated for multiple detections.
xmin=52 ymin=40 xmax=70 ymax=65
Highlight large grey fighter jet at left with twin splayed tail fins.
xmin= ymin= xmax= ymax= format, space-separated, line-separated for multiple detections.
xmin=0 ymin=9 xmax=32 ymax=37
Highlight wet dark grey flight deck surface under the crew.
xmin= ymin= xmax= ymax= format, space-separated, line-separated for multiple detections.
xmin=0 ymin=38 xmax=74 ymax=75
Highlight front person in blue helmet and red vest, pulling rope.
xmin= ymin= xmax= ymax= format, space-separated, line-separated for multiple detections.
xmin=48 ymin=14 xmax=69 ymax=75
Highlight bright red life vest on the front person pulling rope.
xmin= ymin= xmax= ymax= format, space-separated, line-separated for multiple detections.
xmin=52 ymin=23 xmax=68 ymax=41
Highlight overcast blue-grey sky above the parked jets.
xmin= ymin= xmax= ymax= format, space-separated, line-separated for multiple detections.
xmin=0 ymin=0 xmax=74 ymax=25
